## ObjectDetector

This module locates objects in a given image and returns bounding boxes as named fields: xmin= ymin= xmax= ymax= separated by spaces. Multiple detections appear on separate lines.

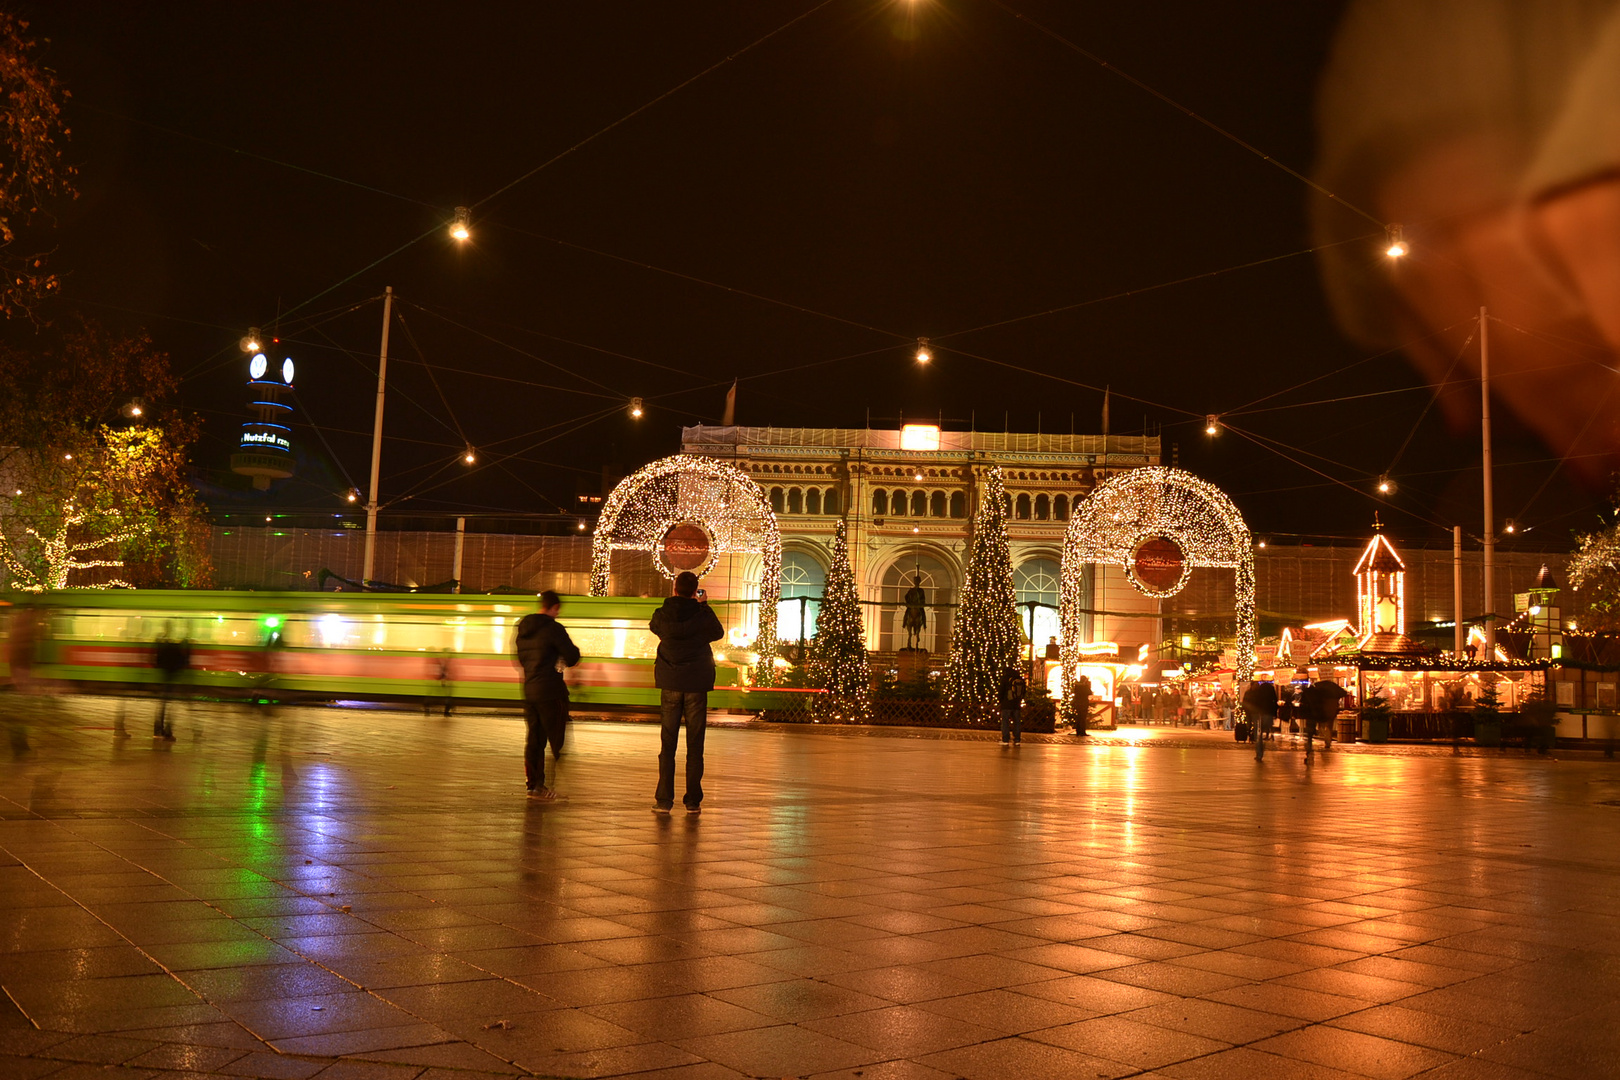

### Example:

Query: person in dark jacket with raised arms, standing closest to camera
xmin=646 ymin=570 xmax=726 ymax=814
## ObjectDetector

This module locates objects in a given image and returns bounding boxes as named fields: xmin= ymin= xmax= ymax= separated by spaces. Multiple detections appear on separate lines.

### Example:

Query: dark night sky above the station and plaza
xmin=19 ymin=0 xmax=1602 ymax=542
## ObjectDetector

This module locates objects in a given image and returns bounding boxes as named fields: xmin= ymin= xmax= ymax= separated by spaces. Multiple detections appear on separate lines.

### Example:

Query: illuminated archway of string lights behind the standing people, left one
xmin=591 ymin=453 xmax=782 ymax=670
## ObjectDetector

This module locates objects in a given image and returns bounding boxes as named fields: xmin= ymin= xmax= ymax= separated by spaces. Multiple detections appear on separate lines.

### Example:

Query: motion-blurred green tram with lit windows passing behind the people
xmin=0 ymin=589 xmax=805 ymax=711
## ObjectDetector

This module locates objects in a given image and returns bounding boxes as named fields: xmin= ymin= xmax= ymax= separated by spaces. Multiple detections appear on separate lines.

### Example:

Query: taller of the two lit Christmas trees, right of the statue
xmin=944 ymin=468 xmax=1021 ymax=717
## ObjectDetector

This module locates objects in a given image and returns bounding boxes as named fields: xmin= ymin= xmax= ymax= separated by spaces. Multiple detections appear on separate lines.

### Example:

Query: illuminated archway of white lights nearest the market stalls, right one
xmin=1058 ymin=466 xmax=1254 ymax=695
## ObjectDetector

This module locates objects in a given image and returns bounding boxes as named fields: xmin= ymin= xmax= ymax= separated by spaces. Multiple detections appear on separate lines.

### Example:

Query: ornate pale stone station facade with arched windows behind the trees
xmin=680 ymin=424 xmax=1160 ymax=659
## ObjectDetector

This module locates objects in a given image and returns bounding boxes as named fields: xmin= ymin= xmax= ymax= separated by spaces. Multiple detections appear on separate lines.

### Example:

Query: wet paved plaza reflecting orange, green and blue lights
xmin=0 ymin=698 xmax=1620 ymax=1080
